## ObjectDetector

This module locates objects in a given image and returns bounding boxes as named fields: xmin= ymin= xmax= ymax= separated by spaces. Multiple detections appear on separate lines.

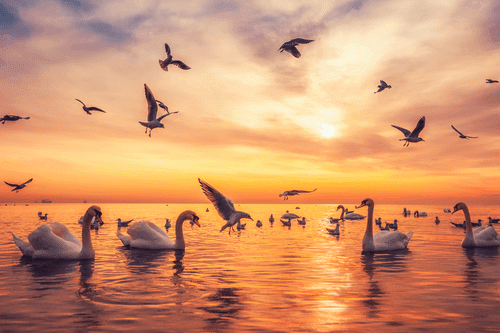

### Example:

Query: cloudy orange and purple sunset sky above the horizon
xmin=0 ymin=0 xmax=500 ymax=206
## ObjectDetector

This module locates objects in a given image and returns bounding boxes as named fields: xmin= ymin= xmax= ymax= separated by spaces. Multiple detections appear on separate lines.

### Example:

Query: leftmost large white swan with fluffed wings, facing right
xmin=12 ymin=206 xmax=102 ymax=259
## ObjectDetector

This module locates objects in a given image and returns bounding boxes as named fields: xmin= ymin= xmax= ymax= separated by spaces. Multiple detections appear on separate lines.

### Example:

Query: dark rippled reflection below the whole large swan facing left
xmin=361 ymin=250 xmax=411 ymax=318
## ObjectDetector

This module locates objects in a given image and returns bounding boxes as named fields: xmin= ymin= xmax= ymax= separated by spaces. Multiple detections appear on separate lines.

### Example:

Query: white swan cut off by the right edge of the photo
xmin=452 ymin=202 xmax=500 ymax=247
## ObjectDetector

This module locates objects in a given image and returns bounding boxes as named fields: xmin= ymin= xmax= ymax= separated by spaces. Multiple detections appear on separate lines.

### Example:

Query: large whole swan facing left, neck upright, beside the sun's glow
xmin=356 ymin=198 xmax=413 ymax=252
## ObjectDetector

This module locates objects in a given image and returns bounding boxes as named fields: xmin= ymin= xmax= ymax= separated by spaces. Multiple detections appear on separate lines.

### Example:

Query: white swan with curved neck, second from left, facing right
xmin=116 ymin=210 xmax=200 ymax=250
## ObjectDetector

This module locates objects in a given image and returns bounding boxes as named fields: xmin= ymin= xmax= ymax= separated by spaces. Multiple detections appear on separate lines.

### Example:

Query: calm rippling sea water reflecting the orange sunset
xmin=0 ymin=203 xmax=500 ymax=332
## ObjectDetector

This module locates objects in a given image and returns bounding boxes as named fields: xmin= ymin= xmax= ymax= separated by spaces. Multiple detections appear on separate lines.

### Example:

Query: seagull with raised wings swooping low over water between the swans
xmin=198 ymin=178 xmax=253 ymax=234
